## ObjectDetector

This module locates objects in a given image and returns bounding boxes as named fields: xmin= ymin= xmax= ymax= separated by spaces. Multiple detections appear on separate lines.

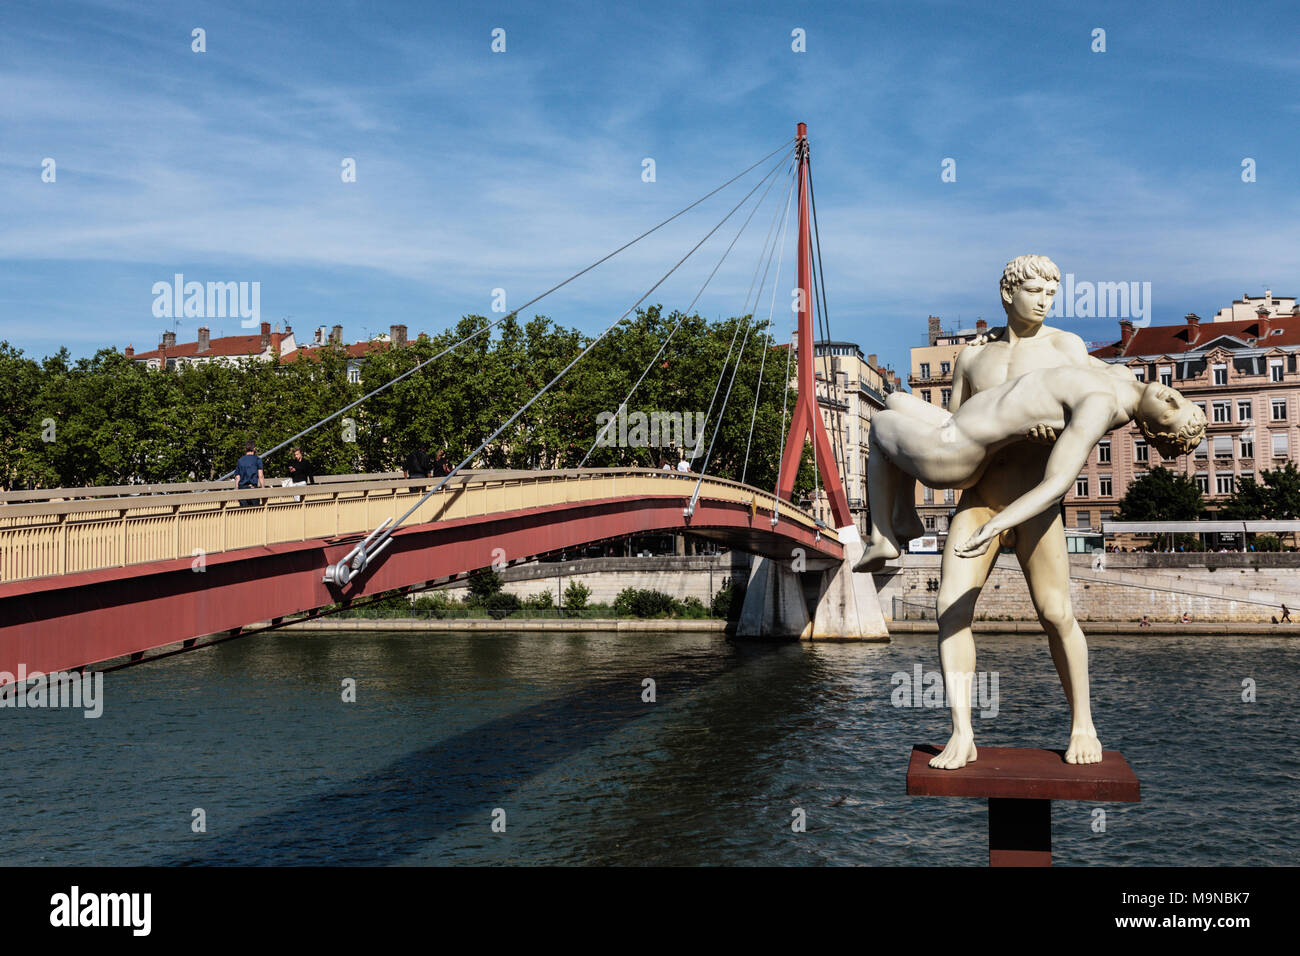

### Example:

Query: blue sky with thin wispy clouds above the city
xmin=0 ymin=0 xmax=1300 ymax=382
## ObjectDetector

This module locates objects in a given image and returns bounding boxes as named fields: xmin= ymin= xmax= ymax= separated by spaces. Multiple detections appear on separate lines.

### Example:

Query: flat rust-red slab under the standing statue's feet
xmin=907 ymin=745 xmax=1141 ymax=803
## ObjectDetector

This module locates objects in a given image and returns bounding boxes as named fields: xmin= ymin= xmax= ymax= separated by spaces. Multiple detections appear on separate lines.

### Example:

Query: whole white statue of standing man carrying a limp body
xmin=859 ymin=255 xmax=1204 ymax=770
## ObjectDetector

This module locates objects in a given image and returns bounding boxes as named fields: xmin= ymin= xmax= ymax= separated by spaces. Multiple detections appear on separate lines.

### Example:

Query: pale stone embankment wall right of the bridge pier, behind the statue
xmin=875 ymin=554 xmax=1300 ymax=622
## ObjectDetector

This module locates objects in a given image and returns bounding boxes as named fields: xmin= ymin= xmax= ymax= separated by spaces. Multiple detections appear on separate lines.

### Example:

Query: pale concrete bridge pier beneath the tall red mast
xmin=736 ymin=524 xmax=889 ymax=641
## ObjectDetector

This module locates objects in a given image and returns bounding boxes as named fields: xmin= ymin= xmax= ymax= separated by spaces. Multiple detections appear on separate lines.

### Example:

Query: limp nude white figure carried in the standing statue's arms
xmin=854 ymin=365 xmax=1205 ymax=571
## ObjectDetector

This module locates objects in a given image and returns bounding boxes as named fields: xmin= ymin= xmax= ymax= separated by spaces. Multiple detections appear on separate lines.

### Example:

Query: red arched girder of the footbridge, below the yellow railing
xmin=0 ymin=497 xmax=842 ymax=674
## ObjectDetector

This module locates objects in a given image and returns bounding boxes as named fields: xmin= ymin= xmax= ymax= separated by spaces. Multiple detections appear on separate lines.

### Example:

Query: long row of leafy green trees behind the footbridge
xmin=0 ymin=306 xmax=813 ymax=494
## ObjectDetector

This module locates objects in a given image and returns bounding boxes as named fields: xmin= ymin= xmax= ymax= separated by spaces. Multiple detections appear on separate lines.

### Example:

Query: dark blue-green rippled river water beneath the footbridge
xmin=0 ymin=631 xmax=1300 ymax=865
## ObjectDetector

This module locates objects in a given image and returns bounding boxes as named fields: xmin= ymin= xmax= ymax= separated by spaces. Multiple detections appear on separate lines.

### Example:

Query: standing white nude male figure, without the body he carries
xmin=930 ymin=255 xmax=1105 ymax=770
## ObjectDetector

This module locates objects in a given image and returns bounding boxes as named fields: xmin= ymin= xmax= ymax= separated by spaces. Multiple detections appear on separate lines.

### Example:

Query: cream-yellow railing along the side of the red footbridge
xmin=0 ymin=468 xmax=839 ymax=583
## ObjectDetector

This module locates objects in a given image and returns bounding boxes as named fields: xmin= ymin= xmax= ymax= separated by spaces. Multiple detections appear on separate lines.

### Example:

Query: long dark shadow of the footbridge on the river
xmin=159 ymin=646 xmax=781 ymax=865
